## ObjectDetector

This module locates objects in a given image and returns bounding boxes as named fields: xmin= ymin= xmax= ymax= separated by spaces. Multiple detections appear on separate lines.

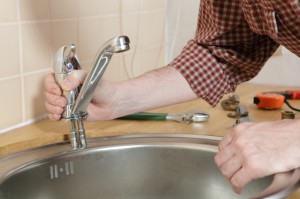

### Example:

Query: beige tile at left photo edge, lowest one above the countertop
xmin=0 ymin=78 xmax=22 ymax=129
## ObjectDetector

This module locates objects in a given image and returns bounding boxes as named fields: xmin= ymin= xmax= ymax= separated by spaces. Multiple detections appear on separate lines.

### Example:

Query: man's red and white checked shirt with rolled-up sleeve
xmin=169 ymin=0 xmax=300 ymax=106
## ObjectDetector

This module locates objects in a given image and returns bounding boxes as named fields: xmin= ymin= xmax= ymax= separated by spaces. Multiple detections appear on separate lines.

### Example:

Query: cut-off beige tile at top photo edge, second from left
xmin=19 ymin=0 xmax=49 ymax=21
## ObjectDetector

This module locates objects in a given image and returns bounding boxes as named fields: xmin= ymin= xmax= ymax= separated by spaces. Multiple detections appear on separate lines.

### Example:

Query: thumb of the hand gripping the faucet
xmin=61 ymin=70 xmax=87 ymax=91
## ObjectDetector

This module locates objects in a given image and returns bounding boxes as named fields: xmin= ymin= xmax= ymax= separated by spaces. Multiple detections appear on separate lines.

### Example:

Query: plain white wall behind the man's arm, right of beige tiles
xmin=166 ymin=0 xmax=300 ymax=87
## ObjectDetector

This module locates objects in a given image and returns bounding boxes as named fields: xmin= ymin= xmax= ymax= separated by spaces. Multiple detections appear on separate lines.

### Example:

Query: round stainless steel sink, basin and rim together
xmin=0 ymin=134 xmax=286 ymax=199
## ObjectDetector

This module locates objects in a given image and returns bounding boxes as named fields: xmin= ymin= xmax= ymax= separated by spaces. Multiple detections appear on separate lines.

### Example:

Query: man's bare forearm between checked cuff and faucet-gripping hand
xmin=113 ymin=66 xmax=197 ymax=117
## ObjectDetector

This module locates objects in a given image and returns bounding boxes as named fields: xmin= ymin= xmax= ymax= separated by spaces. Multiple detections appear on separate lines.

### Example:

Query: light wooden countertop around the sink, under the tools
xmin=0 ymin=83 xmax=300 ymax=199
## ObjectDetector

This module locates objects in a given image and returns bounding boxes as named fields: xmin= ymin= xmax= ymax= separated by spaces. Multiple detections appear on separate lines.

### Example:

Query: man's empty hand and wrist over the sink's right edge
xmin=215 ymin=120 xmax=300 ymax=193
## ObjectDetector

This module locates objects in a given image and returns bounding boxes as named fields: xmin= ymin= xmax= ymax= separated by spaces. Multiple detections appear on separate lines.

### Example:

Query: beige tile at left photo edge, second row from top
xmin=0 ymin=25 xmax=20 ymax=78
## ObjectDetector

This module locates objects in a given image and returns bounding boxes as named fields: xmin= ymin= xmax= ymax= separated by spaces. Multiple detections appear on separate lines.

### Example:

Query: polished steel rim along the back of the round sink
xmin=0 ymin=133 xmax=222 ymax=180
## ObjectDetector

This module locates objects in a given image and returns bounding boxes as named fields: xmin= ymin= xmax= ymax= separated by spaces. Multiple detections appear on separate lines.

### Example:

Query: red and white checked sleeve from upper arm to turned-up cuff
xmin=169 ymin=0 xmax=279 ymax=106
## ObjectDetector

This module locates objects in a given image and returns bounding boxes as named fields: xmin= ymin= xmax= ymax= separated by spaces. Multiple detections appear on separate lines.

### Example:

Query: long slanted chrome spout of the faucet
xmin=72 ymin=36 xmax=130 ymax=117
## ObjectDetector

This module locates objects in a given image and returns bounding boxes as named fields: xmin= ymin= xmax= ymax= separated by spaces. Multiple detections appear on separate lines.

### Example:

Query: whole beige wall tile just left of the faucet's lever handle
xmin=22 ymin=23 xmax=52 ymax=72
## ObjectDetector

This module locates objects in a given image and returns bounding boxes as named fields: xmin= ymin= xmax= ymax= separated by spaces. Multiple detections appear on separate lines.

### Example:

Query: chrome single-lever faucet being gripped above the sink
xmin=53 ymin=36 xmax=130 ymax=149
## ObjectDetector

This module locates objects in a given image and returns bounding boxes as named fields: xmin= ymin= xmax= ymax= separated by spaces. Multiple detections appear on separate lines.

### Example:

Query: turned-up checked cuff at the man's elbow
xmin=169 ymin=40 xmax=236 ymax=107
